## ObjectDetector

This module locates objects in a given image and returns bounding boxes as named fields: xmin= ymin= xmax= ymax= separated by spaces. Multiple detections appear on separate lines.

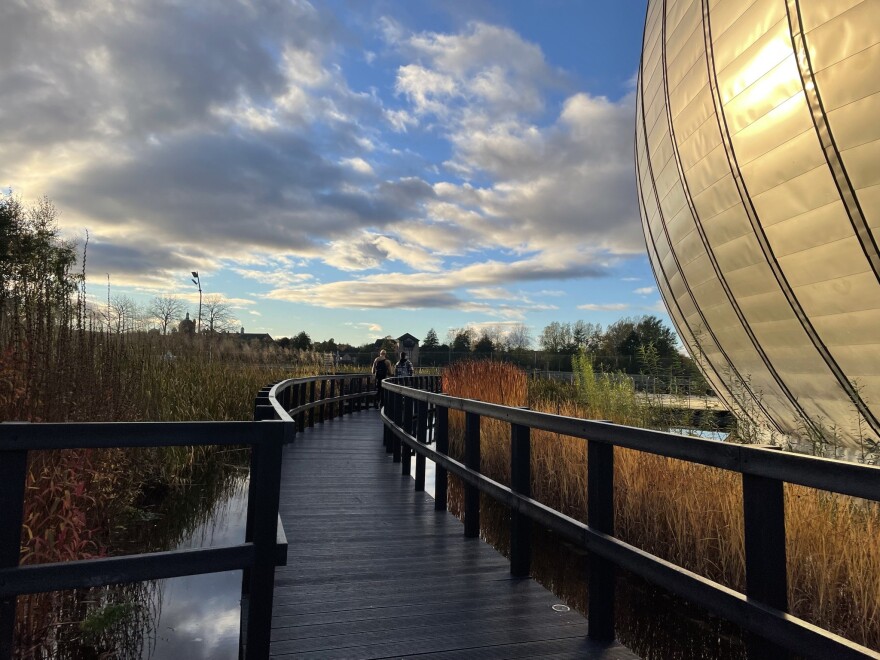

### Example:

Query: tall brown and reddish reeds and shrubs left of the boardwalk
xmin=0 ymin=196 xmax=334 ymax=658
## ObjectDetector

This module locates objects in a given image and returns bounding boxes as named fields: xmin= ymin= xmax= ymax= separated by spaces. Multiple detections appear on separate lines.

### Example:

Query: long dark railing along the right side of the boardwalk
xmin=382 ymin=377 xmax=880 ymax=658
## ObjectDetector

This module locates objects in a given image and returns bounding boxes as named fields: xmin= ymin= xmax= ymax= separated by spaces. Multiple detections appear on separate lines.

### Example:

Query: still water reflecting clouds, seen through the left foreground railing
xmin=141 ymin=478 xmax=247 ymax=660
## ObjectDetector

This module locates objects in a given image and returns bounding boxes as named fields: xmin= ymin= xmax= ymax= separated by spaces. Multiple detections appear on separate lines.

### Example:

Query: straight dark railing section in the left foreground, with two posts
xmin=0 ymin=422 xmax=292 ymax=659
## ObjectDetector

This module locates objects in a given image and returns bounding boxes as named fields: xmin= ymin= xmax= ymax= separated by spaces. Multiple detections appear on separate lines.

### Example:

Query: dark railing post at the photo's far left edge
xmin=0 ymin=451 xmax=27 ymax=658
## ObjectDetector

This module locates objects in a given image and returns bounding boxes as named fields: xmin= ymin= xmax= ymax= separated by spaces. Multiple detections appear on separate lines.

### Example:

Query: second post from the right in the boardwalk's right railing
xmin=587 ymin=440 xmax=615 ymax=641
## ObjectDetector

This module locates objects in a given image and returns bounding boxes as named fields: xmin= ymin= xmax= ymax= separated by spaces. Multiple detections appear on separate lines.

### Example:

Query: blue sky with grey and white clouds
xmin=0 ymin=0 xmax=668 ymax=345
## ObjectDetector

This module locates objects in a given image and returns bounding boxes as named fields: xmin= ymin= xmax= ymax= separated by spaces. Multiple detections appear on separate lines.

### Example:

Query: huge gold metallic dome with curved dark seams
xmin=635 ymin=0 xmax=880 ymax=457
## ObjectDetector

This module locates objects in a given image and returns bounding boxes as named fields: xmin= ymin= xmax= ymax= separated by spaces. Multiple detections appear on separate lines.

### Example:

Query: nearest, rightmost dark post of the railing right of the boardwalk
xmin=742 ymin=473 xmax=788 ymax=658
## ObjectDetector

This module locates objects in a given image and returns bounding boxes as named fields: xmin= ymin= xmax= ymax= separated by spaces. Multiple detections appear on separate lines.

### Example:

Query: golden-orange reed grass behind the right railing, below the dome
xmin=443 ymin=362 xmax=880 ymax=649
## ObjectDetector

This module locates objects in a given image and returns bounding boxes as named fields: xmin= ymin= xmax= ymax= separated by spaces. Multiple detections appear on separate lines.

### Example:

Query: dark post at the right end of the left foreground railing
xmin=245 ymin=423 xmax=283 ymax=660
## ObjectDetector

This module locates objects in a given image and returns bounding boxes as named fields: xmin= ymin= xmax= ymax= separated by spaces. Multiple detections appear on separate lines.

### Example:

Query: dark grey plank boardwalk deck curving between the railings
xmin=272 ymin=410 xmax=635 ymax=660
